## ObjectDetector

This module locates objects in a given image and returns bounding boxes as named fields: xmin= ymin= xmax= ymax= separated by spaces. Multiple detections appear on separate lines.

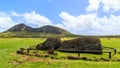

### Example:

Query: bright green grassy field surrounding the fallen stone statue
xmin=0 ymin=38 xmax=120 ymax=68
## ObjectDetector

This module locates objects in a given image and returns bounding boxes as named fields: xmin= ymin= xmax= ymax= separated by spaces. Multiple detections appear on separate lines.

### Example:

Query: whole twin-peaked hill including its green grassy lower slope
xmin=0 ymin=23 xmax=74 ymax=37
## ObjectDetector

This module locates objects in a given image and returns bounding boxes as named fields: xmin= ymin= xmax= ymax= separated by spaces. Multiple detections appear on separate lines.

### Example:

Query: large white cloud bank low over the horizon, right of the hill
xmin=60 ymin=12 xmax=120 ymax=35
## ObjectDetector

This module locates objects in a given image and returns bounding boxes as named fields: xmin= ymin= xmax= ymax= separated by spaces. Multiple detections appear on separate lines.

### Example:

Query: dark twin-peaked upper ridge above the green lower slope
xmin=5 ymin=23 xmax=70 ymax=34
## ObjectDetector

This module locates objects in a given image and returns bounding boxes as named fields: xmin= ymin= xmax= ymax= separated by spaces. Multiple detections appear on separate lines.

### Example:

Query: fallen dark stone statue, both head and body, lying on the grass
xmin=36 ymin=37 xmax=102 ymax=53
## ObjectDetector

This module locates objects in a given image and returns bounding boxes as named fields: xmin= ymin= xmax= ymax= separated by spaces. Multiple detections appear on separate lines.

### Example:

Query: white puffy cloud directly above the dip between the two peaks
xmin=23 ymin=11 xmax=52 ymax=26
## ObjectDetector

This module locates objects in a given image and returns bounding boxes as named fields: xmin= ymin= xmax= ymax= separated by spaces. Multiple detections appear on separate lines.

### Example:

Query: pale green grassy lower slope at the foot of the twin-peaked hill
xmin=0 ymin=31 xmax=77 ymax=38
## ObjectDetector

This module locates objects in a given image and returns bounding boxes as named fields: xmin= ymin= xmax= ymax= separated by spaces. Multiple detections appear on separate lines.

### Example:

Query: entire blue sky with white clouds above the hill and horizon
xmin=0 ymin=0 xmax=120 ymax=35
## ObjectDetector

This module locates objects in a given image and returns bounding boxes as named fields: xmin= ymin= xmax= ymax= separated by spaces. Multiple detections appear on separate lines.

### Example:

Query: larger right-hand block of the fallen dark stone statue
xmin=59 ymin=37 xmax=102 ymax=53
